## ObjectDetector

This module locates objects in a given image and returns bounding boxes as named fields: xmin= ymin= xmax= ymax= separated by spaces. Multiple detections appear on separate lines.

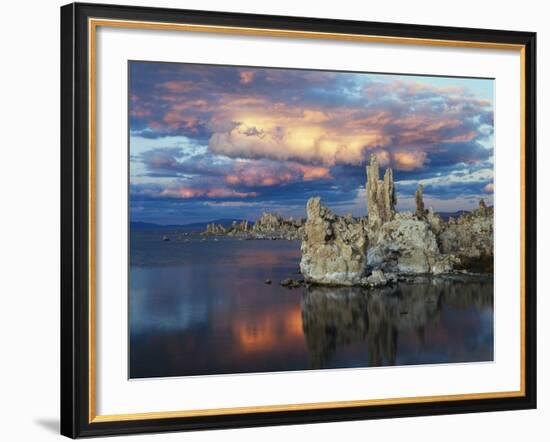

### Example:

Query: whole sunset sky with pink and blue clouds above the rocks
xmin=128 ymin=61 xmax=494 ymax=224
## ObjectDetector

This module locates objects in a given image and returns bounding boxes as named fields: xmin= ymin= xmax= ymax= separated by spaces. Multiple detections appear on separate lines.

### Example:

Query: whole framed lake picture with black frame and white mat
xmin=61 ymin=4 xmax=536 ymax=438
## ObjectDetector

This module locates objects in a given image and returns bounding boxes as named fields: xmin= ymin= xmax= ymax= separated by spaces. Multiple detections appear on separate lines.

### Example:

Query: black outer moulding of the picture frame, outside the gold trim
xmin=60 ymin=3 xmax=537 ymax=438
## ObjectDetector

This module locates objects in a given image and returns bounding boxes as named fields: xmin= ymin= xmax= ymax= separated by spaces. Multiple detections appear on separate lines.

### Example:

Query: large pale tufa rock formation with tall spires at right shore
xmin=300 ymin=155 xmax=493 ymax=287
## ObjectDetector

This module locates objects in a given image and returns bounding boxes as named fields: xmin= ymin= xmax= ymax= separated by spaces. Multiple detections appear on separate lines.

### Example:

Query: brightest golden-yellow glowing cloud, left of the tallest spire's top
xmin=208 ymin=107 xmax=390 ymax=166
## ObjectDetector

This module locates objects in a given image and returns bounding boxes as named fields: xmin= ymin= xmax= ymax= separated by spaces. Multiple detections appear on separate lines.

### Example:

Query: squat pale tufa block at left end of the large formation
xmin=300 ymin=197 xmax=367 ymax=285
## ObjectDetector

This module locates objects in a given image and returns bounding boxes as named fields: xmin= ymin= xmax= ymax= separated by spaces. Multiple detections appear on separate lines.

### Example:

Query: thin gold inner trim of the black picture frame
xmin=88 ymin=18 xmax=526 ymax=423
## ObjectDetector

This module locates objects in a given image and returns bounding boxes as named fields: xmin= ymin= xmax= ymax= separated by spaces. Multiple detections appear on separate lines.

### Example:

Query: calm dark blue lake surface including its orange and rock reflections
xmin=129 ymin=230 xmax=493 ymax=378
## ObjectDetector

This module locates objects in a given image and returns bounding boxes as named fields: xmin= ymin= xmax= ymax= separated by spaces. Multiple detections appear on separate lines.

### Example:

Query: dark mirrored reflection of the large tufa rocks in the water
xmin=301 ymin=279 xmax=493 ymax=368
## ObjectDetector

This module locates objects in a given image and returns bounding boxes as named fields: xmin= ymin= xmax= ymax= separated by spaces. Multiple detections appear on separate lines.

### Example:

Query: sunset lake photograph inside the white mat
xmin=127 ymin=60 xmax=496 ymax=379
